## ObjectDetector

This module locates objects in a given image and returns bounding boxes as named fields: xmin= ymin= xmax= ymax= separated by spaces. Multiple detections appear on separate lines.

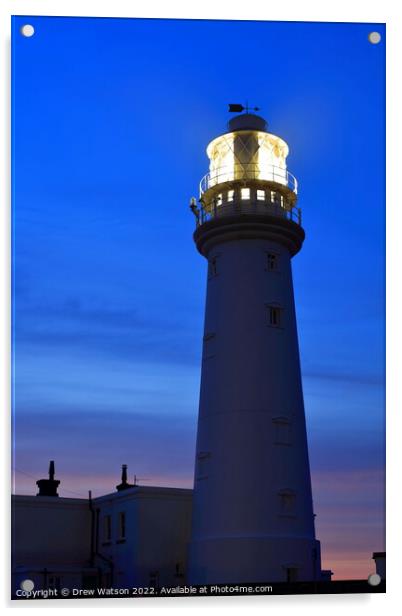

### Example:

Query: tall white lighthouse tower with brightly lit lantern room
xmin=188 ymin=113 xmax=321 ymax=584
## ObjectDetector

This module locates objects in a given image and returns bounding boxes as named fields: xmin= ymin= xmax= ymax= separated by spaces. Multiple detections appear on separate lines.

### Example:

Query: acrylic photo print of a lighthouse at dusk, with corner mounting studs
xmin=12 ymin=17 xmax=385 ymax=599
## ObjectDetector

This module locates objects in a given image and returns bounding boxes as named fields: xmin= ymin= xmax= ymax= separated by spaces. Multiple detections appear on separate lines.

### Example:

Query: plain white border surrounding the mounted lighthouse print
xmin=0 ymin=0 xmax=402 ymax=615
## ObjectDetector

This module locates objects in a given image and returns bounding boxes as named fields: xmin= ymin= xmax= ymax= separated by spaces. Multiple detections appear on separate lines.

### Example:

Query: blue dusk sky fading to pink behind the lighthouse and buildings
xmin=12 ymin=17 xmax=385 ymax=577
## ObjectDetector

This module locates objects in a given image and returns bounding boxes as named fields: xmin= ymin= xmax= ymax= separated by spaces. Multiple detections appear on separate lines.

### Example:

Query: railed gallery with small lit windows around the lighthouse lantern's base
xmin=191 ymin=164 xmax=301 ymax=227
